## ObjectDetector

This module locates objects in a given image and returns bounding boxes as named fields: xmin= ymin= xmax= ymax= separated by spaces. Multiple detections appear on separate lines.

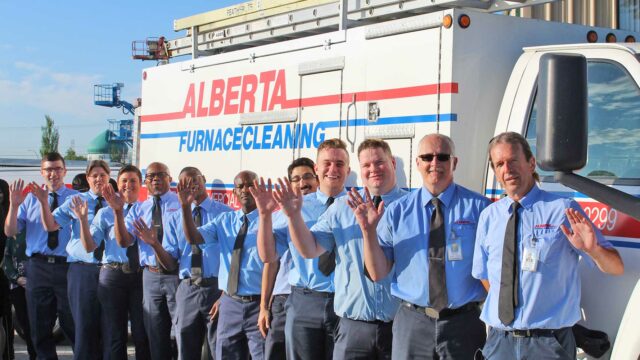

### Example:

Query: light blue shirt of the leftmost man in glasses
xmin=17 ymin=186 xmax=78 ymax=257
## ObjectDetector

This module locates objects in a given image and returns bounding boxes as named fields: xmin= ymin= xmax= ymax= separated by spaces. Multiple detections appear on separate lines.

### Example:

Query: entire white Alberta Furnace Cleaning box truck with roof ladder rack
xmin=134 ymin=0 xmax=640 ymax=359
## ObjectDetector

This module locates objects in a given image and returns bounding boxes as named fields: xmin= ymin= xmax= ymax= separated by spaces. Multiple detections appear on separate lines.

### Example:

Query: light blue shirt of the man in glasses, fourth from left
xmin=124 ymin=191 xmax=181 ymax=266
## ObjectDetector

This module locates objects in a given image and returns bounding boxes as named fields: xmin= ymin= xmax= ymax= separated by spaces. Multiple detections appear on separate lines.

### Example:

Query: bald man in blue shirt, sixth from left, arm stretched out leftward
xmin=183 ymin=170 xmax=264 ymax=360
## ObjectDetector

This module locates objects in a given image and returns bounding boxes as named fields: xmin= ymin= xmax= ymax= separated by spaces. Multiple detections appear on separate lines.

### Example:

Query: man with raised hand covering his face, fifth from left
xmin=168 ymin=167 xmax=231 ymax=360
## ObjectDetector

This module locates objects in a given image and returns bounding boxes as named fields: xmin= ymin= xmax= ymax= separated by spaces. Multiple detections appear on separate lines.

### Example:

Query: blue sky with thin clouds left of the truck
xmin=0 ymin=0 xmax=238 ymax=159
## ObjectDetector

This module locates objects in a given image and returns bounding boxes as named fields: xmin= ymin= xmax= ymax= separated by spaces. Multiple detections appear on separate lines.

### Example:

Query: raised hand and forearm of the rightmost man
xmin=561 ymin=208 xmax=624 ymax=275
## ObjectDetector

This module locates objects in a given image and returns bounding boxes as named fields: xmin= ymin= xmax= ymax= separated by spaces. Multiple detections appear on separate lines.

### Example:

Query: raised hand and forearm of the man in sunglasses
xmin=348 ymin=188 xmax=393 ymax=281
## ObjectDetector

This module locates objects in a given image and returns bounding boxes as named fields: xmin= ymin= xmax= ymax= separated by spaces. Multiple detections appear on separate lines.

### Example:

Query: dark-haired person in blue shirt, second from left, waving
xmin=34 ymin=160 xmax=111 ymax=360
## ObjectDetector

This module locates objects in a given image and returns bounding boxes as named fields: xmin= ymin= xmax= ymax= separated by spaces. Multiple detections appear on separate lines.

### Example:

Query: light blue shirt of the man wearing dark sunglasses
xmin=378 ymin=183 xmax=489 ymax=309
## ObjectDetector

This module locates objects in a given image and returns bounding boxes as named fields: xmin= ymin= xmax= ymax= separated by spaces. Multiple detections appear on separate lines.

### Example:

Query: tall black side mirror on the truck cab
xmin=536 ymin=54 xmax=588 ymax=172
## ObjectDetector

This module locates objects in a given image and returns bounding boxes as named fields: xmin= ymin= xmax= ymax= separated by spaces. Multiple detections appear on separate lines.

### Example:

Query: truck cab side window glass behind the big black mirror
xmin=526 ymin=61 xmax=640 ymax=185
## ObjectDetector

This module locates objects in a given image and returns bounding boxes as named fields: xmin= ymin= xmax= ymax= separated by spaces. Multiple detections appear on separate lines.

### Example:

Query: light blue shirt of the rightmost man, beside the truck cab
xmin=473 ymin=185 xmax=612 ymax=330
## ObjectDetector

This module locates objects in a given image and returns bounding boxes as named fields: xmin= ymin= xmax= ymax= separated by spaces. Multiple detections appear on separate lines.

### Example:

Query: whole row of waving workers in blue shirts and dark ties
xmin=4 ymin=132 xmax=624 ymax=360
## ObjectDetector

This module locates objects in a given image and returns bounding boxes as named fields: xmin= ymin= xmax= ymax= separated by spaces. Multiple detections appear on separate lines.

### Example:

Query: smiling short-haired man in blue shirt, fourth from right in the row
xmin=252 ymin=139 xmax=350 ymax=360
